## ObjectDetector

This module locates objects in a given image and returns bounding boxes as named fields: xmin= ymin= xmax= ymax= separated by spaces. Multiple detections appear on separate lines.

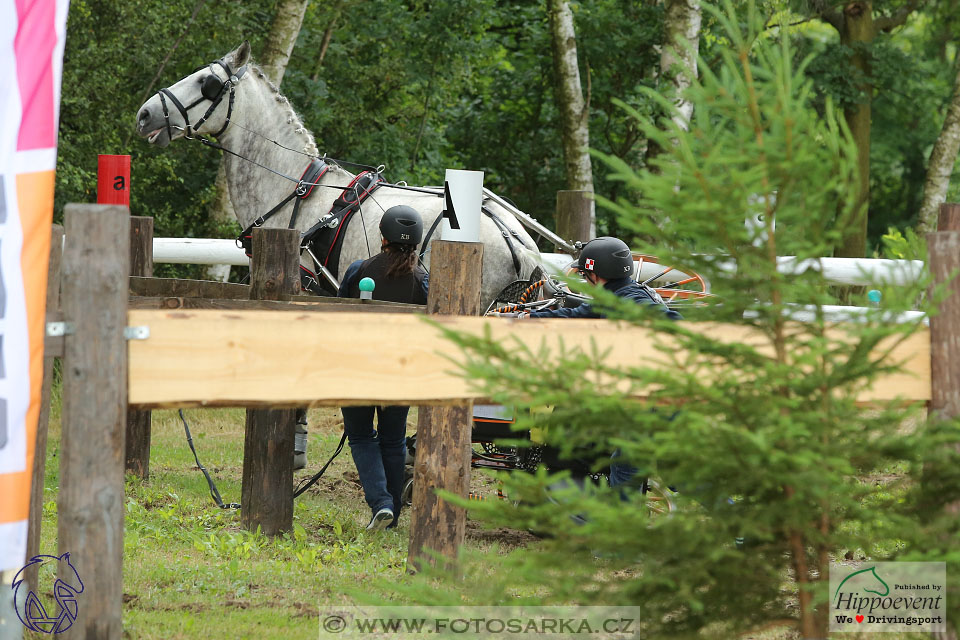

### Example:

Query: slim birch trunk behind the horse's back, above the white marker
xmin=547 ymin=0 xmax=597 ymax=237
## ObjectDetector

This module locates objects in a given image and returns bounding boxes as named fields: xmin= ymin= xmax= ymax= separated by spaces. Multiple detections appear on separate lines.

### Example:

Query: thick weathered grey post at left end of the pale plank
xmin=57 ymin=204 xmax=130 ymax=640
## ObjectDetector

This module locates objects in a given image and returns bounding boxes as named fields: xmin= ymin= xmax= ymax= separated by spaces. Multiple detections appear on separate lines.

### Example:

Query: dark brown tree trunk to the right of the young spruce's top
xmin=835 ymin=0 xmax=877 ymax=258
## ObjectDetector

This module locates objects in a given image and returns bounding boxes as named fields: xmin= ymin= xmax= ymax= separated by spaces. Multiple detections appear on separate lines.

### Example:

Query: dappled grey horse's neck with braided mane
xmin=220 ymin=69 xmax=353 ymax=230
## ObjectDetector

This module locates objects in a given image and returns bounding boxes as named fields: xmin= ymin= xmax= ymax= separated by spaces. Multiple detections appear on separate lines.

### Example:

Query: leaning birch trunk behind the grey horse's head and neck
xmin=207 ymin=0 xmax=308 ymax=281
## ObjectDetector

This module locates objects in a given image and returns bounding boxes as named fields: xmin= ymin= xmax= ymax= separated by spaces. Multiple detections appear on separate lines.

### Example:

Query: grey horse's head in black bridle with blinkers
xmin=137 ymin=41 xmax=250 ymax=147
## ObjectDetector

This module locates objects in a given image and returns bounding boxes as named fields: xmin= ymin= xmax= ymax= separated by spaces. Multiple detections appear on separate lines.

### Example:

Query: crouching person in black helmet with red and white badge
xmin=530 ymin=236 xmax=681 ymax=320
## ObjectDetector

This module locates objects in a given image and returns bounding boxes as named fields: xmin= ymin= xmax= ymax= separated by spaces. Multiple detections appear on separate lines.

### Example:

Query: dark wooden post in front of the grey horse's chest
xmin=240 ymin=228 xmax=300 ymax=536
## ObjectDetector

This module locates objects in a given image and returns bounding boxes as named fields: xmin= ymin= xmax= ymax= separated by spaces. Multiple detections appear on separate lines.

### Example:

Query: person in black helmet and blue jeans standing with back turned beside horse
xmin=337 ymin=205 xmax=428 ymax=529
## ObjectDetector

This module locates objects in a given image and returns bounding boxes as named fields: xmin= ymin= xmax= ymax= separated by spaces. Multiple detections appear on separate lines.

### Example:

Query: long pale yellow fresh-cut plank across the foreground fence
xmin=128 ymin=310 xmax=930 ymax=407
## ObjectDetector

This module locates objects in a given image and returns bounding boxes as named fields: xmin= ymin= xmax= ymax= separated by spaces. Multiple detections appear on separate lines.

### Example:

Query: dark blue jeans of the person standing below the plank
xmin=340 ymin=406 xmax=410 ymax=523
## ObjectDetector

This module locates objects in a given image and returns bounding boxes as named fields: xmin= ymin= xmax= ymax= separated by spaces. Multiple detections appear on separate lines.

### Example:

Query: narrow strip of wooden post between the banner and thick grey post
xmin=27 ymin=224 xmax=63 ymax=588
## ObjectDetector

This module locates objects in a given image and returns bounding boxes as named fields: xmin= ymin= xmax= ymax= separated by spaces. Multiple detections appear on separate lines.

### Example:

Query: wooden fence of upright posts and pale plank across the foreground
xmin=28 ymin=205 xmax=960 ymax=638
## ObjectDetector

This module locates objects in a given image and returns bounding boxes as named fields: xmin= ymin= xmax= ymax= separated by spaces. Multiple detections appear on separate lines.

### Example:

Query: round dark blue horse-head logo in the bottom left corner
xmin=13 ymin=553 xmax=83 ymax=633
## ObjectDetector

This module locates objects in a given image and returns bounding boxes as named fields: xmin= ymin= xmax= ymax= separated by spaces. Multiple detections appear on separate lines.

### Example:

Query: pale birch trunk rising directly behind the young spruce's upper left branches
xmin=660 ymin=0 xmax=702 ymax=130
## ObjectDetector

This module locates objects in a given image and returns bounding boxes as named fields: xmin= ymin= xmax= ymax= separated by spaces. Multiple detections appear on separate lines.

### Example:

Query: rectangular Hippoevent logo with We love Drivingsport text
xmin=830 ymin=562 xmax=947 ymax=633
